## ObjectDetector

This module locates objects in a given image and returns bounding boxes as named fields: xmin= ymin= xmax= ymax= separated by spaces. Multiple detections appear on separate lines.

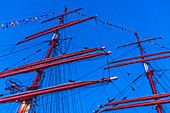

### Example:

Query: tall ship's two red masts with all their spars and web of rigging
xmin=0 ymin=6 xmax=170 ymax=113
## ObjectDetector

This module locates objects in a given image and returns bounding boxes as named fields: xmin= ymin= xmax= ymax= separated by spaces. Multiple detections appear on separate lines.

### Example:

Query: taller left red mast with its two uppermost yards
xmin=14 ymin=7 xmax=97 ymax=113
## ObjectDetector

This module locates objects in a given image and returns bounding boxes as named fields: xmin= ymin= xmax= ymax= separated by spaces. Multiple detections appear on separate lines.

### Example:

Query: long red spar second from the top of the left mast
xmin=16 ymin=16 xmax=97 ymax=45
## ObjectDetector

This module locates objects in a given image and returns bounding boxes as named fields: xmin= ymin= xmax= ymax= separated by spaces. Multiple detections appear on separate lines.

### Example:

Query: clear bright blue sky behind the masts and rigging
xmin=0 ymin=0 xmax=170 ymax=113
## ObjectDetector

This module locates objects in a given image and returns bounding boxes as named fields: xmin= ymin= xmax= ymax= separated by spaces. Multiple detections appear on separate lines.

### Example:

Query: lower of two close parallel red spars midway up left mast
xmin=0 ymin=51 xmax=111 ymax=78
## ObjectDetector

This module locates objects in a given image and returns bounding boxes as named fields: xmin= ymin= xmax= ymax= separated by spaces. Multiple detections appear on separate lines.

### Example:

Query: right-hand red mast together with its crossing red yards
xmin=94 ymin=33 xmax=170 ymax=113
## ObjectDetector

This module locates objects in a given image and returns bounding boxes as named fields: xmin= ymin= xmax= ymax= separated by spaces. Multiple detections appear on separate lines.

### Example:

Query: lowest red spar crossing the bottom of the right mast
xmin=94 ymin=99 xmax=170 ymax=113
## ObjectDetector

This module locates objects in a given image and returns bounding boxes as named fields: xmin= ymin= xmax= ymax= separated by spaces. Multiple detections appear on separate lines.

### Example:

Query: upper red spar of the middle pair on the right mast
xmin=108 ymin=51 xmax=170 ymax=64
